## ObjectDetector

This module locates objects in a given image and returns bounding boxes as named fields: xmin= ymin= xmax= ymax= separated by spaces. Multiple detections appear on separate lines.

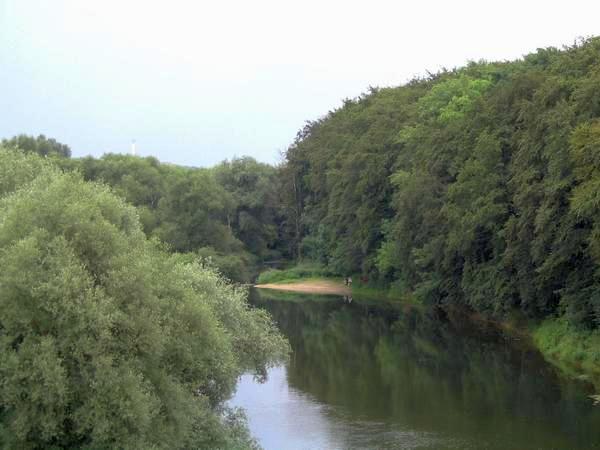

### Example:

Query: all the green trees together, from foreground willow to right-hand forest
xmin=0 ymin=38 xmax=600 ymax=448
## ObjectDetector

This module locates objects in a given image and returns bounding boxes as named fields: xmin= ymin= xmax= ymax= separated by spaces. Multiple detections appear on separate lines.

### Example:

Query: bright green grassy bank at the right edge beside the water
xmin=532 ymin=319 xmax=600 ymax=391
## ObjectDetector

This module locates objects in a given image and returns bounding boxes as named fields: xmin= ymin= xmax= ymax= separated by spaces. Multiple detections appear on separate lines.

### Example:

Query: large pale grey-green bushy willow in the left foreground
xmin=0 ymin=150 xmax=287 ymax=449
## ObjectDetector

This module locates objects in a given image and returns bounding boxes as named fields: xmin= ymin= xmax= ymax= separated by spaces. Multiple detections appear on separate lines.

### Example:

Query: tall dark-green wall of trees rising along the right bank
xmin=281 ymin=38 xmax=600 ymax=328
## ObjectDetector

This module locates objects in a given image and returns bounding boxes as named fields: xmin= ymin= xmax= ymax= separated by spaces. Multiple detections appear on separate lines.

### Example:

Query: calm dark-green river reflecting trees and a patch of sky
xmin=231 ymin=291 xmax=600 ymax=450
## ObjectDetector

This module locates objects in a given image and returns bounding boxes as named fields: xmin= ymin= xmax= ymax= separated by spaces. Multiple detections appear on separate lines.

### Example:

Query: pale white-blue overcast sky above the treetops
xmin=0 ymin=0 xmax=600 ymax=166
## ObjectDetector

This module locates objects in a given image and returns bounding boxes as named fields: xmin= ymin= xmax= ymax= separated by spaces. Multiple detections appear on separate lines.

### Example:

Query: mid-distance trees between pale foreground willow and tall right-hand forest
xmin=60 ymin=155 xmax=290 ymax=282
